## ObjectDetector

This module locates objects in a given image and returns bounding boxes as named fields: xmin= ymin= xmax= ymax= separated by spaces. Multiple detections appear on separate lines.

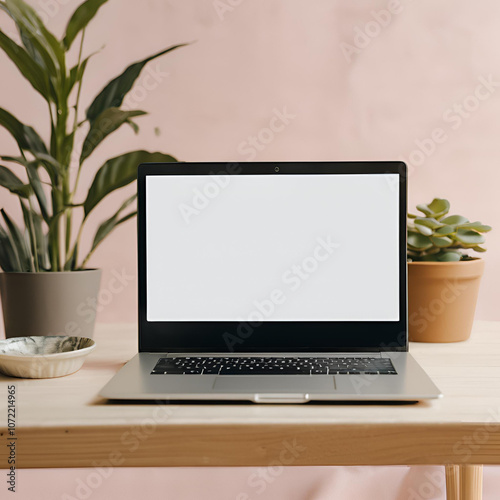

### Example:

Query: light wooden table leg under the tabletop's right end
xmin=446 ymin=465 xmax=483 ymax=500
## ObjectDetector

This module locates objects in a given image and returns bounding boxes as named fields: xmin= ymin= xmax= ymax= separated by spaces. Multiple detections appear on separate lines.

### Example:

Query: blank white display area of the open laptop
xmin=146 ymin=174 xmax=399 ymax=322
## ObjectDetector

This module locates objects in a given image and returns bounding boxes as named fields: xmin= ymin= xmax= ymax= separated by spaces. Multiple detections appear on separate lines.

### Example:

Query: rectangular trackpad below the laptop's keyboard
xmin=213 ymin=375 xmax=336 ymax=394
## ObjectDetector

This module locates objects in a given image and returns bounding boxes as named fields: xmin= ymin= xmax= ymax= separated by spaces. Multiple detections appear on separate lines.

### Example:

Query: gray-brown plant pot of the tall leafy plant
xmin=0 ymin=269 xmax=101 ymax=338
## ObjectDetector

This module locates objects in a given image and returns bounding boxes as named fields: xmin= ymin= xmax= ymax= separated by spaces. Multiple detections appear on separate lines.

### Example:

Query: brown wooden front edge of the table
xmin=7 ymin=424 xmax=500 ymax=467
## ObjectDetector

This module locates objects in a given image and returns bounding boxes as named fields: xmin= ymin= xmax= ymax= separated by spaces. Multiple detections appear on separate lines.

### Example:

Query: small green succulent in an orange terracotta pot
xmin=408 ymin=198 xmax=491 ymax=342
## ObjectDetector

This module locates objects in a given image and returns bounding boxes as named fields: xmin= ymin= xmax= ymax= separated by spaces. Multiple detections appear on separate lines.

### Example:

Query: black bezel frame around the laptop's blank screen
xmin=137 ymin=162 xmax=408 ymax=353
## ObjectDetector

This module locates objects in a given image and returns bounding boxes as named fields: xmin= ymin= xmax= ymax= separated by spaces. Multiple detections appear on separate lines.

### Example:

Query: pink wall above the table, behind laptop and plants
xmin=0 ymin=0 xmax=500 ymax=321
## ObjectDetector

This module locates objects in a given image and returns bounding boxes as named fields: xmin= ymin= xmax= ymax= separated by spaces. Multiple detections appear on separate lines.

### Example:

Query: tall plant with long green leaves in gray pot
xmin=0 ymin=0 xmax=186 ymax=337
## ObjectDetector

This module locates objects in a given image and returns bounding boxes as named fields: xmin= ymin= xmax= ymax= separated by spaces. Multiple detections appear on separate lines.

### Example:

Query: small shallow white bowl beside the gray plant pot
xmin=0 ymin=335 xmax=96 ymax=378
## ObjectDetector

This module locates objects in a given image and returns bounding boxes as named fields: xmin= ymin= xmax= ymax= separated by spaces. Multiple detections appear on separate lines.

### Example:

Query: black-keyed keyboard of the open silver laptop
xmin=151 ymin=356 xmax=396 ymax=375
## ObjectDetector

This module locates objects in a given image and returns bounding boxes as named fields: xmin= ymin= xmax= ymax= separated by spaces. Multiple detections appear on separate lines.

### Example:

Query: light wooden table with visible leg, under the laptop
xmin=0 ymin=322 xmax=500 ymax=500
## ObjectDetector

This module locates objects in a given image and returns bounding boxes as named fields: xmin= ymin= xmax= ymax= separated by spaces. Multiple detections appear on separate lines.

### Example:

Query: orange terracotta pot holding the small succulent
xmin=408 ymin=259 xmax=484 ymax=342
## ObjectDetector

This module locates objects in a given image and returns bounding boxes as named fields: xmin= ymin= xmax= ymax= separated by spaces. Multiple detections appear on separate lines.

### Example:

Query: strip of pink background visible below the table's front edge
xmin=11 ymin=465 xmax=498 ymax=500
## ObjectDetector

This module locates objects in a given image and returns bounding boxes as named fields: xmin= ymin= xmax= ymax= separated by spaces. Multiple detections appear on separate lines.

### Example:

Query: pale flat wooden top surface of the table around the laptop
xmin=0 ymin=321 xmax=500 ymax=427
